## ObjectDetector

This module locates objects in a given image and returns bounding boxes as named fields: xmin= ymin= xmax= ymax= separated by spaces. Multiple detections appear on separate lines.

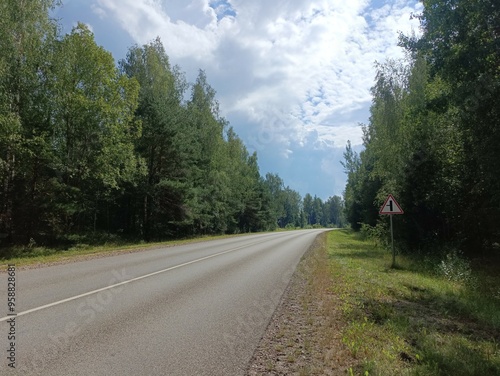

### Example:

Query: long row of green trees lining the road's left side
xmin=0 ymin=0 xmax=345 ymax=252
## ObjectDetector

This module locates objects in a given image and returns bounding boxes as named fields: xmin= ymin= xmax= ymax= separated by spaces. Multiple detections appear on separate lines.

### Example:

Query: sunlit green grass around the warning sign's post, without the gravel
xmin=328 ymin=230 xmax=500 ymax=376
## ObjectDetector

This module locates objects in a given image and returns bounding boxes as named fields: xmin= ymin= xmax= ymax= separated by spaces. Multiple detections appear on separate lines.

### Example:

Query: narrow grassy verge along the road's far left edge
xmin=0 ymin=234 xmax=250 ymax=271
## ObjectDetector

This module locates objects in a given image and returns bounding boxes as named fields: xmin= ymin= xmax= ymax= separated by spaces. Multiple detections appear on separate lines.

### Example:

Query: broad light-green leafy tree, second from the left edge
xmin=50 ymin=24 xmax=141 ymax=220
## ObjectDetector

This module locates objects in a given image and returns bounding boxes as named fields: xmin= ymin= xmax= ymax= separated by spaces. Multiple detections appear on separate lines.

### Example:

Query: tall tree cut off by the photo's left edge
xmin=0 ymin=0 xmax=60 ymax=242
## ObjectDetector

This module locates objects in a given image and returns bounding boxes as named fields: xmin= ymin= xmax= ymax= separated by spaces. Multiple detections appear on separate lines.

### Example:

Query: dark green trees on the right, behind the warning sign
xmin=343 ymin=0 xmax=500 ymax=256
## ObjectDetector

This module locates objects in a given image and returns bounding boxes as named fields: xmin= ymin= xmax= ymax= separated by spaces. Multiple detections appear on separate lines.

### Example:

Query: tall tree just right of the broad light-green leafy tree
xmin=119 ymin=39 xmax=192 ymax=240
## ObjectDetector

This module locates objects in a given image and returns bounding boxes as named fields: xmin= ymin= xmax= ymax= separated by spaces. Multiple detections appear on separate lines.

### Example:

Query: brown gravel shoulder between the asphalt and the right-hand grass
xmin=247 ymin=233 xmax=358 ymax=376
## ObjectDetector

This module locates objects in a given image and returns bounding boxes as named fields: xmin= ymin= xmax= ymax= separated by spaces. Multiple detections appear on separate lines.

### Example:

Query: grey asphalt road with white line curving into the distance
xmin=0 ymin=230 xmax=324 ymax=376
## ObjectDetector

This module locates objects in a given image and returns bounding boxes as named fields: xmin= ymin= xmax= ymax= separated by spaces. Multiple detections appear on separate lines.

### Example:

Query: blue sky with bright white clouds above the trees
xmin=54 ymin=0 xmax=422 ymax=200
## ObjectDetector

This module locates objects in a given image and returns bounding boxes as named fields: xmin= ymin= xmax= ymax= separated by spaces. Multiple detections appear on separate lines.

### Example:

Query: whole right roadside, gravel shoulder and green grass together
xmin=247 ymin=230 xmax=500 ymax=376
